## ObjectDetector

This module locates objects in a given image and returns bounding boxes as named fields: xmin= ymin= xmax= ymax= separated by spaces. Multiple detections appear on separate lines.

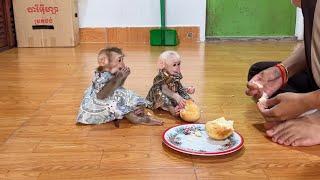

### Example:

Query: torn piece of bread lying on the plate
xmin=206 ymin=117 xmax=234 ymax=140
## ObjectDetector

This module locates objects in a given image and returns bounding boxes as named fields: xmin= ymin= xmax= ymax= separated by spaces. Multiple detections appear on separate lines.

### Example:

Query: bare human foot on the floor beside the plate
xmin=267 ymin=113 xmax=320 ymax=146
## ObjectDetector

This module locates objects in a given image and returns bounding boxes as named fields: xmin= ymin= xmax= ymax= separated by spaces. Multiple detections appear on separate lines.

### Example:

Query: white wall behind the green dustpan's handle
xmin=78 ymin=0 xmax=206 ymax=41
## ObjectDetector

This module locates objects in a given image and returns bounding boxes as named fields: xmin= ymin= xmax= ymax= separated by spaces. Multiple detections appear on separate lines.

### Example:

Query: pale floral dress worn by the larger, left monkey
xmin=77 ymin=71 xmax=150 ymax=124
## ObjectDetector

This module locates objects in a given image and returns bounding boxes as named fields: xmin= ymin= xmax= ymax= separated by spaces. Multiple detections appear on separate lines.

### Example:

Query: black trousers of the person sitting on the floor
xmin=248 ymin=62 xmax=319 ymax=95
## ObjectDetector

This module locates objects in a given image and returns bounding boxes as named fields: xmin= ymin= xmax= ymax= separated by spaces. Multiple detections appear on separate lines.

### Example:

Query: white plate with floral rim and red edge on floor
xmin=162 ymin=124 xmax=243 ymax=156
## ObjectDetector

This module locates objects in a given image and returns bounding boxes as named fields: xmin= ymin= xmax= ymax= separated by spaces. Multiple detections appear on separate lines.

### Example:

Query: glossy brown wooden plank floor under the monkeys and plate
xmin=0 ymin=42 xmax=320 ymax=179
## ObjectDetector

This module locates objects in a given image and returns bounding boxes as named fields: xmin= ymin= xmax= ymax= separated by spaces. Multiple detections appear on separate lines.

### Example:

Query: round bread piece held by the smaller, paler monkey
xmin=180 ymin=100 xmax=200 ymax=122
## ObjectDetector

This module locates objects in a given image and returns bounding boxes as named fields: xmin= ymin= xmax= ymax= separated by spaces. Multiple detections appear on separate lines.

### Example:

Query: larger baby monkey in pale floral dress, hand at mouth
xmin=77 ymin=47 xmax=163 ymax=127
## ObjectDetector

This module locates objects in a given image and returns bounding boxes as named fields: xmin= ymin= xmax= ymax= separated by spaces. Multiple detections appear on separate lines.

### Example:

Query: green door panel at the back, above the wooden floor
xmin=206 ymin=0 xmax=296 ymax=37
